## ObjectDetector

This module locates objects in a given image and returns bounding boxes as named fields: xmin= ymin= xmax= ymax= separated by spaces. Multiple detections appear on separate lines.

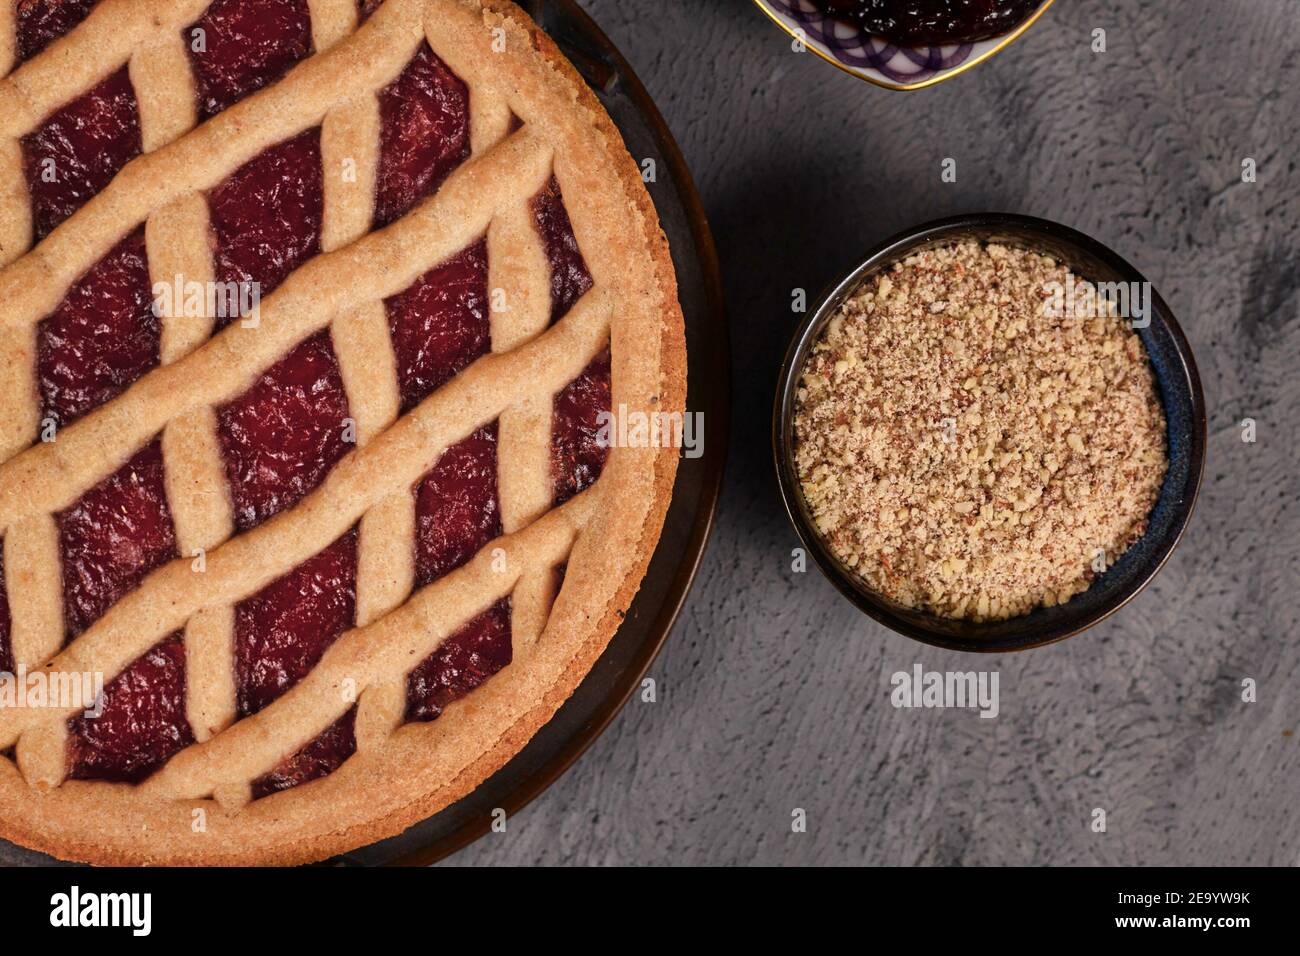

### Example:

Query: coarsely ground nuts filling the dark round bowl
xmin=794 ymin=242 xmax=1167 ymax=620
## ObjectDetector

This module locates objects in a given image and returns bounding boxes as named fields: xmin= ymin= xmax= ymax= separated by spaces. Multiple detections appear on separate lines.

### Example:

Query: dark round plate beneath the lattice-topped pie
xmin=0 ymin=0 xmax=731 ymax=866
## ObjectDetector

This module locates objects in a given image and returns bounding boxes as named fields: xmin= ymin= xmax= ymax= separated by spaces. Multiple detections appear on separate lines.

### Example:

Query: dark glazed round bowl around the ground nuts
xmin=772 ymin=213 xmax=1205 ymax=653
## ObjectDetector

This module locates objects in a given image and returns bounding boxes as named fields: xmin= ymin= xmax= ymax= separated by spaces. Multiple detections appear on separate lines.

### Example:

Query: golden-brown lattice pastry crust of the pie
xmin=0 ymin=0 xmax=685 ymax=864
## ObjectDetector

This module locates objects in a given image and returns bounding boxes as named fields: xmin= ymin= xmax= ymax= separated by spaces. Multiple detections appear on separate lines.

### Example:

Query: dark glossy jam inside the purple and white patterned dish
xmin=813 ymin=0 xmax=1043 ymax=47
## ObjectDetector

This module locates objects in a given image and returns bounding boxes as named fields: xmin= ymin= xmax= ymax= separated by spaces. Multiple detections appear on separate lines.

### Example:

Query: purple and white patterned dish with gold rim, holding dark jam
xmin=754 ymin=0 xmax=1056 ymax=90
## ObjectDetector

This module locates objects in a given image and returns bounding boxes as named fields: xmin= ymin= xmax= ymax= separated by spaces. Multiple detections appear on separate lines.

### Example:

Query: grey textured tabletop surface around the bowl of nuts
xmin=450 ymin=0 xmax=1300 ymax=865
